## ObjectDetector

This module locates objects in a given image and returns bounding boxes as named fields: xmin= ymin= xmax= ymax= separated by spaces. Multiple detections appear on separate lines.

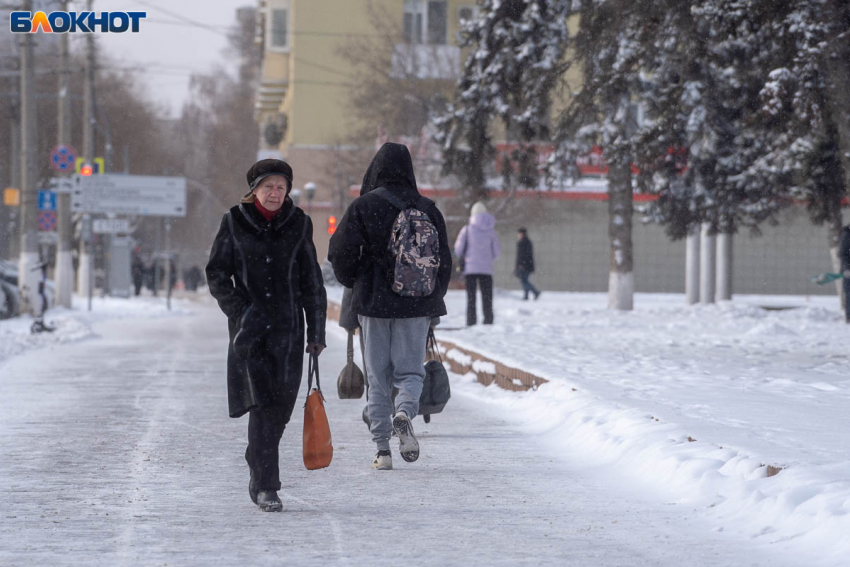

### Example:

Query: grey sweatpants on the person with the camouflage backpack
xmin=358 ymin=315 xmax=431 ymax=450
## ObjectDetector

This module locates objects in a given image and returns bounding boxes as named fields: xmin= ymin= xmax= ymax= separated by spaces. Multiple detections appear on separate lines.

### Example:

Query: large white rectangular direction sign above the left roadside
xmin=71 ymin=174 xmax=186 ymax=217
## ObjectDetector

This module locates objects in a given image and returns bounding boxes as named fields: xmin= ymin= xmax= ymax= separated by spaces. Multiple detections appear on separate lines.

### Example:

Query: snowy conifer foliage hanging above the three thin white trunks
xmin=637 ymin=0 xmax=784 ymax=242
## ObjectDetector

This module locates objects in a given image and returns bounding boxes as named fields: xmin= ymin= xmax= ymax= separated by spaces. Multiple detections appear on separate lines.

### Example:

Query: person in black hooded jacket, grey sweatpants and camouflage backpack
xmin=328 ymin=143 xmax=452 ymax=470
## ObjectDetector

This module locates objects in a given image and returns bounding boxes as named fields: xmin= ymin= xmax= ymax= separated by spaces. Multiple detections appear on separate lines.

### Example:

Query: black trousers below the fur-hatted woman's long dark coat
xmin=245 ymin=400 xmax=295 ymax=492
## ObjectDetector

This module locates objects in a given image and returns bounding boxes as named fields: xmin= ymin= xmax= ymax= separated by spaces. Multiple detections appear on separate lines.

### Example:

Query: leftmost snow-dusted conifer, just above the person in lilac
xmin=436 ymin=0 xmax=571 ymax=207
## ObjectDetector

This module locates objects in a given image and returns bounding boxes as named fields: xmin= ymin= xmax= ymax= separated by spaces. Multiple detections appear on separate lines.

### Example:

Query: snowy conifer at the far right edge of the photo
xmin=743 ymin=0 xmax=850 ymax=301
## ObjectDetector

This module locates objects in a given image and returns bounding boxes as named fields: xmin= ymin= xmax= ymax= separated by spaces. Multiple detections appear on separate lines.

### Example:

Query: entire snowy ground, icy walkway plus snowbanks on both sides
xmin=0 ymin=288 xmax=850 ymax=567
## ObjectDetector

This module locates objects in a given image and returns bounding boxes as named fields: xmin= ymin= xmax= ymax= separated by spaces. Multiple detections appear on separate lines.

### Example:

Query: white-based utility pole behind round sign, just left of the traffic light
xmin=56 ymin=0 xmax=74 ymax=309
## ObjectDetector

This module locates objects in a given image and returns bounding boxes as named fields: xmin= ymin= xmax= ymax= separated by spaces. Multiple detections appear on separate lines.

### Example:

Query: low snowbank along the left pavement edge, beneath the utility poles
xmin=0 ymin=297 xmax=192 ymax=361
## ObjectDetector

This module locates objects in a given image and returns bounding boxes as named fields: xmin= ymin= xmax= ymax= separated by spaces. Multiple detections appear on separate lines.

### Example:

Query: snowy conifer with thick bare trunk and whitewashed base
xmin=549 ymin=0 xmax=653 ymax=310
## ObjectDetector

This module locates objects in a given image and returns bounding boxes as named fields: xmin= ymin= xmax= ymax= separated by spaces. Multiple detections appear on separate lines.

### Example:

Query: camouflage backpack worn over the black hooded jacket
xmin=374 ymin=187 xmax=440 ymax=297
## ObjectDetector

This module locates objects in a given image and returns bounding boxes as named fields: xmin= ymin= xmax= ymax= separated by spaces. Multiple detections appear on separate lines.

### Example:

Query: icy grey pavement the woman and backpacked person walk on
xmin=0 ymin=300 xmax=812 ymax=567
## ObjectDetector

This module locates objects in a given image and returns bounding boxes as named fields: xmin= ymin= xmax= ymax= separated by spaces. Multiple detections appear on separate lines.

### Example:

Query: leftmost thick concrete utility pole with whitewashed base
xmin=18 ymin=0 xmax=41 ymax=315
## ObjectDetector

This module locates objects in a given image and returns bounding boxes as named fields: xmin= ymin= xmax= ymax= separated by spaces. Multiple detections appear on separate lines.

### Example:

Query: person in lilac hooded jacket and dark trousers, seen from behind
xmin=455 ymin=201 xmax=502 ymax=326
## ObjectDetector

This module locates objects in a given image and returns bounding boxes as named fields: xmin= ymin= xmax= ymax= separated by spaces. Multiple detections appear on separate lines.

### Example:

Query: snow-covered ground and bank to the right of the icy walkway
xmin=332 ymin=288 xmax=850 ymax=565
